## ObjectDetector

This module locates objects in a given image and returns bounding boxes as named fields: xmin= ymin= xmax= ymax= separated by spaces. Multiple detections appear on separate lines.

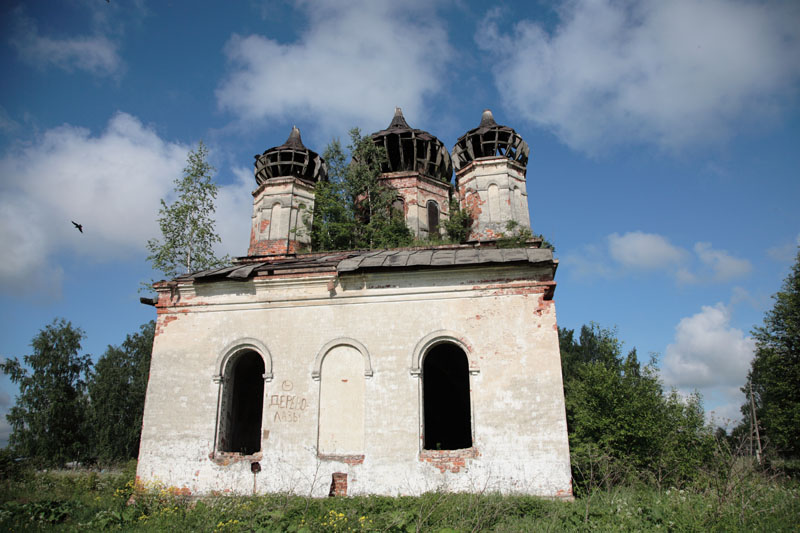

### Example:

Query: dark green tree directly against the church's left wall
xmin=89 ymin=321 xmax=155 ymax=462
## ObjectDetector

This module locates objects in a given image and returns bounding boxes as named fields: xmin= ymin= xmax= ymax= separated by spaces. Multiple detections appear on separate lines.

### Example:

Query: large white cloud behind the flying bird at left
xmin=0 ymin=113 xmax=188 ymax=290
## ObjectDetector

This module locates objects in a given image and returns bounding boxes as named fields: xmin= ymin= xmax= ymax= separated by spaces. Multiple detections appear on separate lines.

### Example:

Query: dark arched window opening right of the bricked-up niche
xmin=422 ymin=343 xmax=472 ymax=450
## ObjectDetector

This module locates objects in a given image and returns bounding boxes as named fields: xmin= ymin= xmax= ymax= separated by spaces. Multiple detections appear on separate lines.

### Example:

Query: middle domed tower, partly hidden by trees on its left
xmin=371 ymin=107 xmax=453 ymax=238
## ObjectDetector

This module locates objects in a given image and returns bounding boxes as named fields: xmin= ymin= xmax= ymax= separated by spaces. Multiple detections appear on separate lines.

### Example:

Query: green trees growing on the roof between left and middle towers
xmin=311 ymin=128 xmax=413 ymax=251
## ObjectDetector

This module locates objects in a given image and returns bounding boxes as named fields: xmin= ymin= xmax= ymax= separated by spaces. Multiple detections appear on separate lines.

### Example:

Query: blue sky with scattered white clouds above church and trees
xmin=0 ymin=0 xmax=800 ymax=444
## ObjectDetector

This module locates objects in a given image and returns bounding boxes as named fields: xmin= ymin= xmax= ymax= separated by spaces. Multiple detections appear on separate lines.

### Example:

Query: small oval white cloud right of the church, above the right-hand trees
xmin=608 ymin=231 xmax=686 ymax=270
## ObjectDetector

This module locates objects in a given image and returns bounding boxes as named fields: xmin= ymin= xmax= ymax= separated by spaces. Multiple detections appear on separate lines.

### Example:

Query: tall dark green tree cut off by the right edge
xmin=742 ymin=246 xmax=800 ymax=458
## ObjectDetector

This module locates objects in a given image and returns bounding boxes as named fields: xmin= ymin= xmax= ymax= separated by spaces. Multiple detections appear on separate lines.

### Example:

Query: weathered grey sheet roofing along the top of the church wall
xmin=170 ymin=245 xmax=558 ymax=282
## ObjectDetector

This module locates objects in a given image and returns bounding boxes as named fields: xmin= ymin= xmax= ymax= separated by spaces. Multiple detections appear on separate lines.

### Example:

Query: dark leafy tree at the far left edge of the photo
xmin=2 ymin=319 xmax=91 ymax=465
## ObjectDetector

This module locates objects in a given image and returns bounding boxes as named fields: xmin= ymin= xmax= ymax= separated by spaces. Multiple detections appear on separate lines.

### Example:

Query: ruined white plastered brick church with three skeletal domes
xmin=137 ymin=109 xmax=572 ymax=498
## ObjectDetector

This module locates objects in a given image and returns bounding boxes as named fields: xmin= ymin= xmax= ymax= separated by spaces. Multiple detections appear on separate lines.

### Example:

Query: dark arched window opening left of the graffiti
xmin=219 ymin=351 xmax=264 ymax=455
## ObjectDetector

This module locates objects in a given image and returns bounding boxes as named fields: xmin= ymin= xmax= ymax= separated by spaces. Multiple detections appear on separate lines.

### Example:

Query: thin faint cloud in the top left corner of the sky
xmin=9 ymin=12 xmax=122 ymax=76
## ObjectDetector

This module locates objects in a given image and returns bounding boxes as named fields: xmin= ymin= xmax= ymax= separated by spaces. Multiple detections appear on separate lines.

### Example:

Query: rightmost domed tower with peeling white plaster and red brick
xmin=452 ymin=109 xmax=531 ymax=241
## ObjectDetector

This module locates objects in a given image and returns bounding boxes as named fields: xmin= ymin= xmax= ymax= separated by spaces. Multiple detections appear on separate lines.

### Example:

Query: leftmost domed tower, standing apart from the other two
xmin=247 ymin=127 xmax=328 ymax=256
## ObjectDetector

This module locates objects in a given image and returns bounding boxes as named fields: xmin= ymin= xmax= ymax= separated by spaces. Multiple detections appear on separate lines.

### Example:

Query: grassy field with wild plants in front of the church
xmin=0 ymin=464 xmax=800 ymax=532
